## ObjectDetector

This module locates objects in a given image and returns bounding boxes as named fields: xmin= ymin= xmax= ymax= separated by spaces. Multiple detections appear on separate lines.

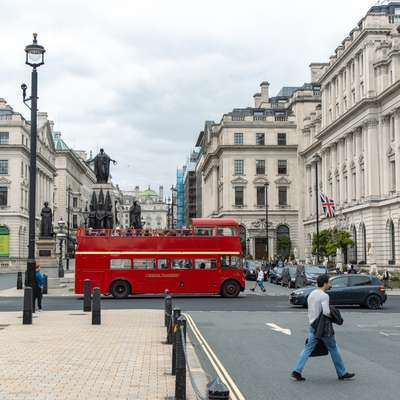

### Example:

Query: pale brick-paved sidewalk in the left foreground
xmin=0 ymin=310 xmax=195 ymax=400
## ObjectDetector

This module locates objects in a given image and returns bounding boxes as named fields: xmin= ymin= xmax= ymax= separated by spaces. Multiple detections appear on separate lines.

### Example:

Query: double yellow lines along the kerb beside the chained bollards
xmin=184 ymin=314 xmax=246 ymax=400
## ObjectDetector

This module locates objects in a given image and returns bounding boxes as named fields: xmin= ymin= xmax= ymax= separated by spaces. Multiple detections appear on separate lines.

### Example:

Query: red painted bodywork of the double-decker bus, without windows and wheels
xmin=75 ymin=218 xmax=245 ymax=294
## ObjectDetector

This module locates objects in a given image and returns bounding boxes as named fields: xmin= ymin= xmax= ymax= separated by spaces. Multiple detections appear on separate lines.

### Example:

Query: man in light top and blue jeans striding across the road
xmin=291 ymin=274 xmax=355 ymax=381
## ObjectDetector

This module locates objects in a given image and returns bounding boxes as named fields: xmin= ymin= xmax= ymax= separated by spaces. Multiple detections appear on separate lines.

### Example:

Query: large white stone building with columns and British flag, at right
xmin=299 ymin=3 xmax=400 ymax=266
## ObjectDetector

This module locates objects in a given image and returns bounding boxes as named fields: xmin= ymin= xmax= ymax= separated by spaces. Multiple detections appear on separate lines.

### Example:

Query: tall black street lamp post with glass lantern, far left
xmin=21 ymin=33 xmax=46 ymax=290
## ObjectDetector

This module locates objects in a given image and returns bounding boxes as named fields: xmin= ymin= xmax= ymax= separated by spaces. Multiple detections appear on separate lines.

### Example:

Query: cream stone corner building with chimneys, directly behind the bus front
xmin=196 ymin=82 xmax=300 ymax=258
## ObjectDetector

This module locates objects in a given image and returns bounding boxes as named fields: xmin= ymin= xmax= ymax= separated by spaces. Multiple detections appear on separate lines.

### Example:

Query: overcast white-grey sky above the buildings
xmin=0 ymin=0 xmax=376 ymax=195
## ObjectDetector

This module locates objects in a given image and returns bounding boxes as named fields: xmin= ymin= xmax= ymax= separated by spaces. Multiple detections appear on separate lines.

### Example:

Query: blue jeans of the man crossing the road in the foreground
xmin=294 ymin=327 xmax=346 ymax=376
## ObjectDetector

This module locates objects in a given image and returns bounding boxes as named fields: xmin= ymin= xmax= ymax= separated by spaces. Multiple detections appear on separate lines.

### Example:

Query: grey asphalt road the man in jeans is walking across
xmin=190 ymin=309 xmax=400 ymax=400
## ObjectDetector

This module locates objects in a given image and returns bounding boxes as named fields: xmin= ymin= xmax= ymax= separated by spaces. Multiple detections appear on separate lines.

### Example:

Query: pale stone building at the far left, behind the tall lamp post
xmin=0 ymin=99 xmax=56 ymax=270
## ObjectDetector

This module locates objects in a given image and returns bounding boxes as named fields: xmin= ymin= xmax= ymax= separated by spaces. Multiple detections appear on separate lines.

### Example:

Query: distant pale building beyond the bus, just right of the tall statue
xmin=121 ymin=186 xmax=168 ymax=229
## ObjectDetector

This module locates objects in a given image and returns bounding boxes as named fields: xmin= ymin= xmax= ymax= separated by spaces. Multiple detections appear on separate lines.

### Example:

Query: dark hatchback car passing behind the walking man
xmin=289 ymin=274 xmax=387 ymax=310
